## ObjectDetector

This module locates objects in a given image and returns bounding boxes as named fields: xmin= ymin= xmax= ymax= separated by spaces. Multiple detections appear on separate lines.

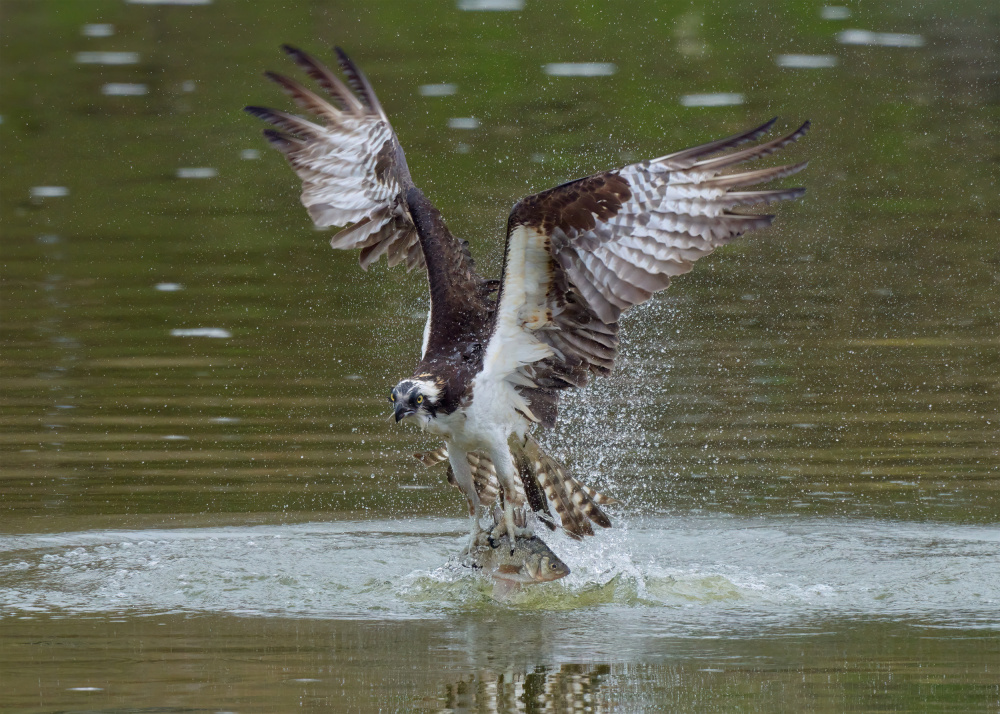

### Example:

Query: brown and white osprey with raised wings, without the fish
xmin=246 ymin=45 xmax=809 ymax=548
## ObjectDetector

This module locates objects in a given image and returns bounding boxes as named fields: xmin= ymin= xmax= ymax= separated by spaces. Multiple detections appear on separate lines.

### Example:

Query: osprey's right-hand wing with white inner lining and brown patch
xmin=484 ymin=119 xmax=809 ymax=426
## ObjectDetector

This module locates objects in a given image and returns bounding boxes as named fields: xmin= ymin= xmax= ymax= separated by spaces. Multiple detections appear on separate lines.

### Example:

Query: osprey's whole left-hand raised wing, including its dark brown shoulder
xmin=246 ymin=45 xmax=495 ymax=370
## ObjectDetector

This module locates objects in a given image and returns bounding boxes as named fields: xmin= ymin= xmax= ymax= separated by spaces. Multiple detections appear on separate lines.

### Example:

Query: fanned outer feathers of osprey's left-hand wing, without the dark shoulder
xmin=246 ymin=45 xmax=424 ymax=270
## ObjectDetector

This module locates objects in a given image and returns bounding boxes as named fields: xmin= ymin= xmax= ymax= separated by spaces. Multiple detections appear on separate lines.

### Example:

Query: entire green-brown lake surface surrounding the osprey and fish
xmin=0 ymin=0 xmax=1000 ymax=712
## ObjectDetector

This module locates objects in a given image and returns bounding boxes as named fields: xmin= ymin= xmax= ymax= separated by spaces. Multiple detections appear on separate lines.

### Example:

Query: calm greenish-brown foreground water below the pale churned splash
xmin=0 ymin=614 xmax=1000 ymax=714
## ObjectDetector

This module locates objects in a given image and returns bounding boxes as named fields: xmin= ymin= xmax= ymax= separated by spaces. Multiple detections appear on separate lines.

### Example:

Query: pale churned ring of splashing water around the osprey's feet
xmin=0 ymin=516 xmax=1000 ymax=631
